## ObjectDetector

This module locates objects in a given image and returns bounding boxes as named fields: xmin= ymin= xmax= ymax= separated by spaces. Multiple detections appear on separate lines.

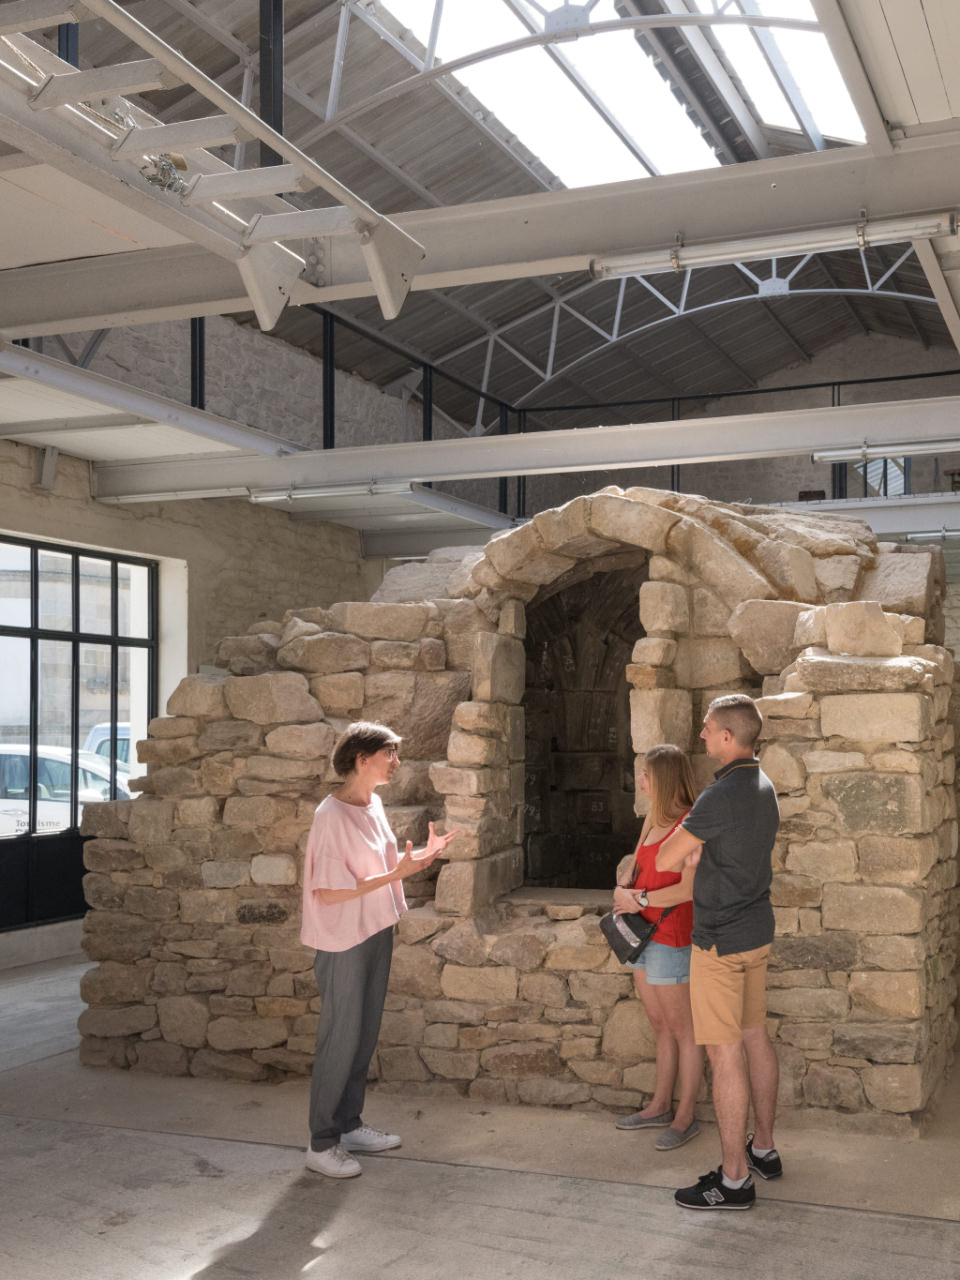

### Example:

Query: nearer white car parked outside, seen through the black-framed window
xmin=0 ymin=742 xmax=131 ymax=837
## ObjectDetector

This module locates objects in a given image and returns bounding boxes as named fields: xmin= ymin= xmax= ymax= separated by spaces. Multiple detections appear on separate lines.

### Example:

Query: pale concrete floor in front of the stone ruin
xmin=0 ymin=961 xmax=960 ymax=1280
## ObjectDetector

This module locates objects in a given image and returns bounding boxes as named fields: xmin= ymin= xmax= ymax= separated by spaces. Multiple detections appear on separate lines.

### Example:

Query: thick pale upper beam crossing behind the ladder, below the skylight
xmin=0 ymin=129 xmax=960 ymax=337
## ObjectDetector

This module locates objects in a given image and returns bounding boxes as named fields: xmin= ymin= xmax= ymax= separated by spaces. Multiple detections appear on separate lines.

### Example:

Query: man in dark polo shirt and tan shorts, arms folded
xmin=657 ymin=694 xmax=783 ymax=1208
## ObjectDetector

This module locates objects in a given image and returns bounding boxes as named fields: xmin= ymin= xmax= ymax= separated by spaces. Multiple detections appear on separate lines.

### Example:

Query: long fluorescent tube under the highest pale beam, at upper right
xmin=590 ymin=212 xmax=956 ymax=280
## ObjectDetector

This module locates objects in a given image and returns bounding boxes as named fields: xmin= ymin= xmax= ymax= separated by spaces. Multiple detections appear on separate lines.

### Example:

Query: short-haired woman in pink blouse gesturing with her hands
xmin=301 ymin=721 xmax=457 ymax=1178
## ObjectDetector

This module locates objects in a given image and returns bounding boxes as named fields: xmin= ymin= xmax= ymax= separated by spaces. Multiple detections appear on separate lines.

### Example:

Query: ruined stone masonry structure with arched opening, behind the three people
xmin=81 ymin=488 xmax=960 ymax=1134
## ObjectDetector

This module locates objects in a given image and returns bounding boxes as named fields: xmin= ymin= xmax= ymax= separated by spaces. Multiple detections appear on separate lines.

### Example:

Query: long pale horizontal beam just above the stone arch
xmin=95 ymin=396 xmax=960 ymax=502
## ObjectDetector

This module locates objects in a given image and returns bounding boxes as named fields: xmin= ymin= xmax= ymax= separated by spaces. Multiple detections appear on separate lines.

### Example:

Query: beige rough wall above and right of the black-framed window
xmin=0 ymin=440 xmax=381 ymax=682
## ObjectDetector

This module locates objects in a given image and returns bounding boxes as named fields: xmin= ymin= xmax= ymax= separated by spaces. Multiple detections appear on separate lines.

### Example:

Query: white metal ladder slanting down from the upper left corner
xmin=0 ymin=0 xmax=425 ymax=329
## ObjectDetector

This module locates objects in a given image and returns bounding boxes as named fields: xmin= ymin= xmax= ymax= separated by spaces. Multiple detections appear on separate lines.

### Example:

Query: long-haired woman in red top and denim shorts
xmin=613 ymin=744 xmax=704 ymax=1151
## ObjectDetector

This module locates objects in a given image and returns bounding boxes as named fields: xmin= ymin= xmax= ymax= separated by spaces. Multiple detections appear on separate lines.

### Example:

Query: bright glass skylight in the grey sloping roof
xmin=383 ymin=0 xmax=864 ymax=187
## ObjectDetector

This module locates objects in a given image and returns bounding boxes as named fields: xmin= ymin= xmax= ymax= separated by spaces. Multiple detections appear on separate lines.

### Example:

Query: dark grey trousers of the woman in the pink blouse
xmin=310 ymin=925 xmax=393 ymax=1151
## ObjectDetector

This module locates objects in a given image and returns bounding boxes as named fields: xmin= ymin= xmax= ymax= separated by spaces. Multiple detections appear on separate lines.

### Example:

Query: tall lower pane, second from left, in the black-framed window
xmin=37 ymin=637 xmax=73 ymax=832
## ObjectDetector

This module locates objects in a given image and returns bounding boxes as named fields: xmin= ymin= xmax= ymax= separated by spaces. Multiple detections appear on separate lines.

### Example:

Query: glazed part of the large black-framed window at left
xmin=0 ymin=536 xmax=157 ymax=841
